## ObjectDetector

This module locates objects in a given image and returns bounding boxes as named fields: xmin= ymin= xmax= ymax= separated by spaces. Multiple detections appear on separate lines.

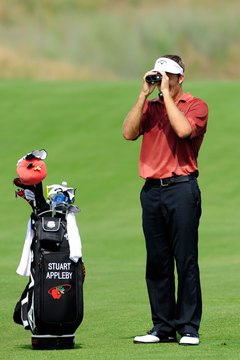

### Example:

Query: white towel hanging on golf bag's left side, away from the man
xmin=17 ymin=219 xmax=34 ymax=276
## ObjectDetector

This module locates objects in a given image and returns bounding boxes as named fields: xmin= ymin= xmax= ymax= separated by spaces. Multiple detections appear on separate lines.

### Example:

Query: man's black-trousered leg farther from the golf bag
xmin=164 ymin=180 xmax=202 ymax=335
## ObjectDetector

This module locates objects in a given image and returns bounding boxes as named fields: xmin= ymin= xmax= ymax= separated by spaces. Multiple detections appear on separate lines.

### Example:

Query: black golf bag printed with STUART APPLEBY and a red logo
xmin=13 ymin=153 xmax=85 ymax=349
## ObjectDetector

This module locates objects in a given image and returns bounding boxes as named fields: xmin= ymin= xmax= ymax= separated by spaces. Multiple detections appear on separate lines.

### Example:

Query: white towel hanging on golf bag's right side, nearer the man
xmin=67 ymin=212 xmax=82 ymax=262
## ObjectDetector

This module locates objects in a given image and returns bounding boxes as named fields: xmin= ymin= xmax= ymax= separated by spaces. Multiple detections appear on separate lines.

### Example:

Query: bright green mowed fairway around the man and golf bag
xmin=0 ymin=81 xmax=240 ymax=360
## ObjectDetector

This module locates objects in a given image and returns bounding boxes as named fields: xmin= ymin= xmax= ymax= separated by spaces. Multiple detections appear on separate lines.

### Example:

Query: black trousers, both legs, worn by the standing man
xmin=141 ymin=178 xmax=202 ymax=335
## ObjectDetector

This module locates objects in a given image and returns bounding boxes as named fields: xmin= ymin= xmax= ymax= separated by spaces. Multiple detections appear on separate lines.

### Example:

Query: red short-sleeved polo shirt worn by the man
xmin=139 ymin=93 xmax=208 ymax=179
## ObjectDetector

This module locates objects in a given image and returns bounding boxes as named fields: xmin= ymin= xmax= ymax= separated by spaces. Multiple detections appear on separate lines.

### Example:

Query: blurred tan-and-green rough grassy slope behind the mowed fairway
xmin=0 ymin=0 xmax=240 ymax=80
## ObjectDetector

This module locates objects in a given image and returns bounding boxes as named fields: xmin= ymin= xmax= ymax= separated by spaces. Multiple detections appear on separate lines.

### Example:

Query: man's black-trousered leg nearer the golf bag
xmin=141 ymin=185 xmax=176 ymax=335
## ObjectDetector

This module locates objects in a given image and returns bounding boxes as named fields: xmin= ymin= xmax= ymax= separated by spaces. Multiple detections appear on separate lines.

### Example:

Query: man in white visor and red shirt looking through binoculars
xmin=123 ymin=55 xmax=208 ymax=345
